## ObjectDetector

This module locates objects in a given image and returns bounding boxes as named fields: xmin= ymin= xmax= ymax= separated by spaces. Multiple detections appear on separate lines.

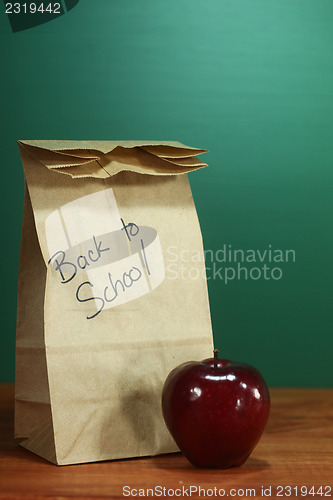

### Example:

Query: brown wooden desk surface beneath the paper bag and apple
xmin=0 ymin=385 xmax=333 ymax=500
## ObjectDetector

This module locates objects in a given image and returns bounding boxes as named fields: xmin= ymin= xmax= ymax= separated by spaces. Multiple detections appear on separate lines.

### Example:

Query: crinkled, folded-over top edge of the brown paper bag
xmin=19 ymin=141 xmax=207 ymax=179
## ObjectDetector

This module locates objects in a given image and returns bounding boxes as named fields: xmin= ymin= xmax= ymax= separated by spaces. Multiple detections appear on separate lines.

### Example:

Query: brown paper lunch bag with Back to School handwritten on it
xmin=15 ymin=141 xmax=213 ymax=465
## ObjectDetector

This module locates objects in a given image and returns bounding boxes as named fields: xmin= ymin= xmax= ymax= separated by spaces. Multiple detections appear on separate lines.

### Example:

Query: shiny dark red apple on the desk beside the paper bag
xmin=162 ymin=349 xmax=270 ymax=469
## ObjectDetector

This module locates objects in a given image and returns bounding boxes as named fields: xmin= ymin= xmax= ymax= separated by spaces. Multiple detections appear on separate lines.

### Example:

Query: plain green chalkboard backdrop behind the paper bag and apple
xmin=0 ymin=0 xmax=333 ymax=386
